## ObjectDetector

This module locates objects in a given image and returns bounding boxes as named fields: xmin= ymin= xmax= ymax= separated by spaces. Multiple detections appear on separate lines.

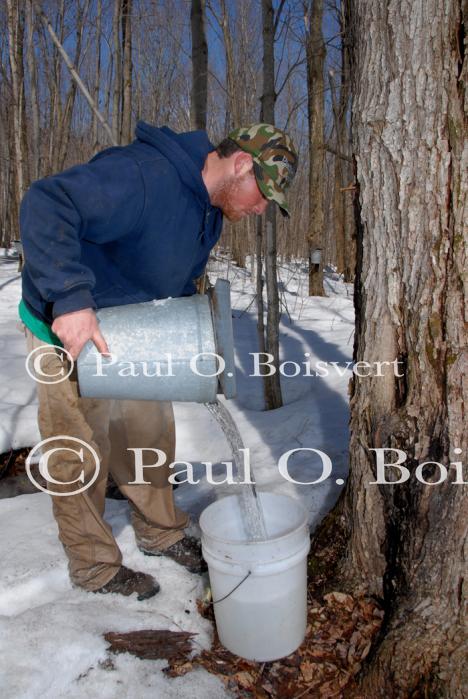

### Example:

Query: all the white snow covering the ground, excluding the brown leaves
xmin=0 ymin=251 xmax=354 ymax=699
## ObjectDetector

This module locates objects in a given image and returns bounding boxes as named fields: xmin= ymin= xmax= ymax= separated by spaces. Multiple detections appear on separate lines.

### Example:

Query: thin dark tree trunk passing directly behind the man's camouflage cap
xmin=260 ymin=0 xmax=283 ymax=410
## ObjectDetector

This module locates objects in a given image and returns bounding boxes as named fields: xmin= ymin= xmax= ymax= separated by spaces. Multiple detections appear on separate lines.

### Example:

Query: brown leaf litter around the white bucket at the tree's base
xmin=165 ymin=591 xmax=383 ymax=699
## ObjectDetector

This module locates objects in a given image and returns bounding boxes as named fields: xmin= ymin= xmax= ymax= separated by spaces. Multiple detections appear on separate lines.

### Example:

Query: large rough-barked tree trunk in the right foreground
xmin=320 ymin=0 xmax=468 ymax=699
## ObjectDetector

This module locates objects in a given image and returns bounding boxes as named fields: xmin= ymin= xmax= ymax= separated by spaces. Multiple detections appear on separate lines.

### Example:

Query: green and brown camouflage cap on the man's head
xmin=228 ymin=124 xmax=297 ymax=216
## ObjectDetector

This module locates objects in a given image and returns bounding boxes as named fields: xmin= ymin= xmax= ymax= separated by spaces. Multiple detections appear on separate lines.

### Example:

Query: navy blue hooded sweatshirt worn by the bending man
xmin=20 ymin=122 xmax=222 ymax=324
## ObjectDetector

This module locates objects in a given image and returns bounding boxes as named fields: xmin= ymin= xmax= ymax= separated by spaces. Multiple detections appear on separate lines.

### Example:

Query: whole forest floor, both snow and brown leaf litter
xmin=0 ymin=256 xmax=381 ymax=699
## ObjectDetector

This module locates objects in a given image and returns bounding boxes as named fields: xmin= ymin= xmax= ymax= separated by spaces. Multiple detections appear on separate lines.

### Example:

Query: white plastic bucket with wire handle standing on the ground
xmin=200 ymin=493 xmax=310 ymax=662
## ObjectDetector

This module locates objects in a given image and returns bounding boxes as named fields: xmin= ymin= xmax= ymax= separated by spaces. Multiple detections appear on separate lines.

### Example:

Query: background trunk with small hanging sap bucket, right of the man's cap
xmin=306 ymin=0 xmax=326 ymax=296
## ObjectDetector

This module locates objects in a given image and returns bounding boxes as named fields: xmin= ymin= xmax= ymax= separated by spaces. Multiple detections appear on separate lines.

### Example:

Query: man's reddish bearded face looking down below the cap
xmin=214 ymin=171 xmax=268 ymax=223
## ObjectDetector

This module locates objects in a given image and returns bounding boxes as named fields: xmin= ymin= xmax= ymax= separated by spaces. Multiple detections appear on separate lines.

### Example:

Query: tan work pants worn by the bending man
xmin=25 ymin=329 xmax=188 ymax=590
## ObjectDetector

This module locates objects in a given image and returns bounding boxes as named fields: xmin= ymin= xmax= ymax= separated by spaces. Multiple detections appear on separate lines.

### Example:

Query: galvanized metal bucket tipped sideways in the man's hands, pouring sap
xmin=77 ymin=279 xmax=236 ymax=403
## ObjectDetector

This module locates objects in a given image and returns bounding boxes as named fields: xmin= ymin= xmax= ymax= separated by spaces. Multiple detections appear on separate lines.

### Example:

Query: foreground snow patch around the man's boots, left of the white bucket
xmin=0 ymin=493 xmax=227 ymax=699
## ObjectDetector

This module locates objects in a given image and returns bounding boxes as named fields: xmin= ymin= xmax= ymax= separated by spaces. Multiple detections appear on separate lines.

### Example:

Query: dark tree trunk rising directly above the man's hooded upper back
xmin=190 ymin=0 xmax=208 ymax=129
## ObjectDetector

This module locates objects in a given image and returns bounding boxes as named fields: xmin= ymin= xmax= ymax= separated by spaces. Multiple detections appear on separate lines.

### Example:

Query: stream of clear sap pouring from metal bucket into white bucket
xmin=205 ymin=401 xmax=268 ymax=541
